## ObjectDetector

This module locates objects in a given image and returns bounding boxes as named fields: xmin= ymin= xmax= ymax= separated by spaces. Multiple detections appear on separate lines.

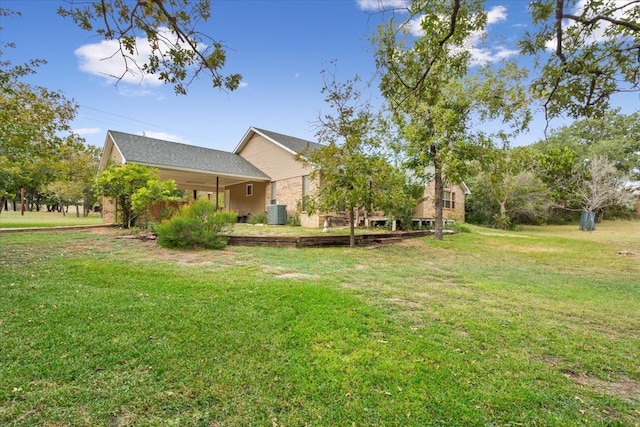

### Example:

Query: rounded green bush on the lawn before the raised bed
xmin=156 ymin=200 xmax=237 ymax=249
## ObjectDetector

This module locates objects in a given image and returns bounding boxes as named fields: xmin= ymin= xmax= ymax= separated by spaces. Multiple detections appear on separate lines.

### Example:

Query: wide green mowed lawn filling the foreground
xmin=0 ymin=222 xmax=640 ymax=427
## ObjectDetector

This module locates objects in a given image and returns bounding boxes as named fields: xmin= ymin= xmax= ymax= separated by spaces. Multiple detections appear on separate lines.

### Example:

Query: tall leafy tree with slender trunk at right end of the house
xmin=375 ymin=0 xmax=529 ymax=240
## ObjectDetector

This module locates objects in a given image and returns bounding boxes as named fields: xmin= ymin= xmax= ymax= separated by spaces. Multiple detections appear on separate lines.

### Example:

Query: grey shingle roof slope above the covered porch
xmin=109 ymin=130 xmax=269 ymax=179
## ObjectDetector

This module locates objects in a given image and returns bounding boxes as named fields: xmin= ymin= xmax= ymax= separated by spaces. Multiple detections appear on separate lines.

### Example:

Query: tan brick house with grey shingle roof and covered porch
xmin=99 ymin=127 xmax=469 ymax=227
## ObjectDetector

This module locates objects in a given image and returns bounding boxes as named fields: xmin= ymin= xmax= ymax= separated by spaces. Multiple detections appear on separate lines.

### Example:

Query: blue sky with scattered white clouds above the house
xmin=0 ymin=0 xmax=639 ymax=151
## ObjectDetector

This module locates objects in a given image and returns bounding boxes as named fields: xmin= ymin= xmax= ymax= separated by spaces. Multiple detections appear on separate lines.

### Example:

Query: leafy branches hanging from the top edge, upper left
xmin=58 ymin=0 xmax=242 ymax=94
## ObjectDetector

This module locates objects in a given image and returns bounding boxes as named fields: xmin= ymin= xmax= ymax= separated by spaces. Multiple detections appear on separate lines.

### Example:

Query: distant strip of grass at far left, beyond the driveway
xmin=0 ymin=207 xmax=102 ymax=228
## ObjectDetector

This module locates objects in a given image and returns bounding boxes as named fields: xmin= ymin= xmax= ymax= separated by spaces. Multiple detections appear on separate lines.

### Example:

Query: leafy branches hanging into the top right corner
xmin=520 ymin=0 xmax=640 ymax=120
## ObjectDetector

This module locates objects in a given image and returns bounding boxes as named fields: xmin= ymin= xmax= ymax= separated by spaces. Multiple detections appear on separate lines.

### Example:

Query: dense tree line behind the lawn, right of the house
xmin=466 ymin=112 xmax=640 ymax=228
